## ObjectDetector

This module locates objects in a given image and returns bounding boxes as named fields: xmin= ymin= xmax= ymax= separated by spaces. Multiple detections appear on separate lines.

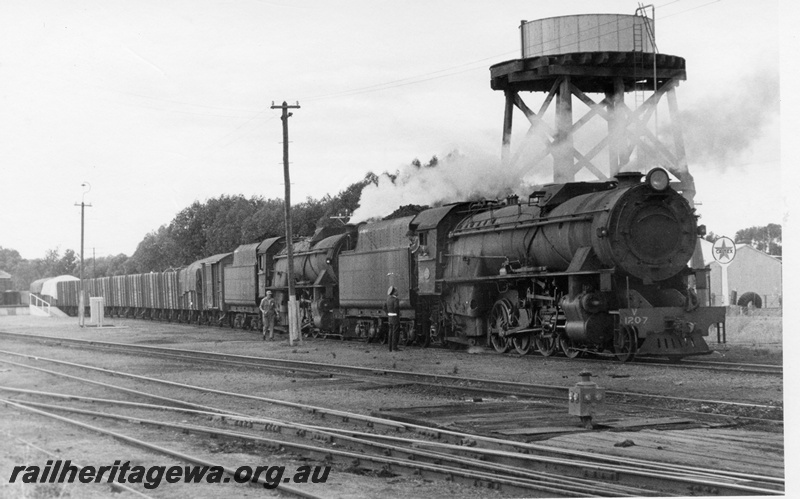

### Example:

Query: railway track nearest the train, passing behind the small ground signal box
xmin=0 ymin=332 xmax=783 ymax=425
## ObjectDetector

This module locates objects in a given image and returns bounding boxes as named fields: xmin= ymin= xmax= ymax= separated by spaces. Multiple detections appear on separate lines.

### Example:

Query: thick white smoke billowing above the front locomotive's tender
xmin=350 ymin=151 xmax=530 ymax=223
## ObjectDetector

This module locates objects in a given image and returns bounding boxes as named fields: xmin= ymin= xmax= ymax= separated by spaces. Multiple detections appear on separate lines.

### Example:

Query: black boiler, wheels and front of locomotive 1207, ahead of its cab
xmin=439 ymin=168 xmax=724 ymax=360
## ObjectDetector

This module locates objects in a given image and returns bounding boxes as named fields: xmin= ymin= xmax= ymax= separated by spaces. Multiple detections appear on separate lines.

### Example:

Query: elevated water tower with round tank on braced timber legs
xmin=491 ymin=7 xmax=695 ymax=203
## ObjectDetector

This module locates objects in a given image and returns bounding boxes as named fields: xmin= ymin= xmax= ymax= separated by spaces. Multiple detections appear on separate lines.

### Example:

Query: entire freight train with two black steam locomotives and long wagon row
xmin=51 ymin=168 xmax=725 ymax=361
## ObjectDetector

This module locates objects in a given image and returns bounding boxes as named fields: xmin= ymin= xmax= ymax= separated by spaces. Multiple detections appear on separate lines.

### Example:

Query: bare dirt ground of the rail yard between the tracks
xmin=0 ymin=316 xmax=795 ymax=498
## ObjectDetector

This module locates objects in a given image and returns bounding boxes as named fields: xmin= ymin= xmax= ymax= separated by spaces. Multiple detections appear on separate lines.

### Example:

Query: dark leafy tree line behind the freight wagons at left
xmin=0 ymin=172 xmax=378 ymax=290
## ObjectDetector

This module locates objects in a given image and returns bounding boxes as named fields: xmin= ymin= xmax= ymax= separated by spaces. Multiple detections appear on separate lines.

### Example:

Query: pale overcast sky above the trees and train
xmin=0 ymin=0 xmax=786 ymax=259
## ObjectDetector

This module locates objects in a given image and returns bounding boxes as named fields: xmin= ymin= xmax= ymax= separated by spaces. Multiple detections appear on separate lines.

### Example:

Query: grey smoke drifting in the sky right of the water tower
xmin=681 ymin=68 xmax=780 ymax=170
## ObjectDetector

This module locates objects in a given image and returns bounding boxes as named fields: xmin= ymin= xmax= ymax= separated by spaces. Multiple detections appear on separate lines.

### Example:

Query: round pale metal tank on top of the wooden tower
xmin=520 ymin=14 xmax=655 ymax=59
